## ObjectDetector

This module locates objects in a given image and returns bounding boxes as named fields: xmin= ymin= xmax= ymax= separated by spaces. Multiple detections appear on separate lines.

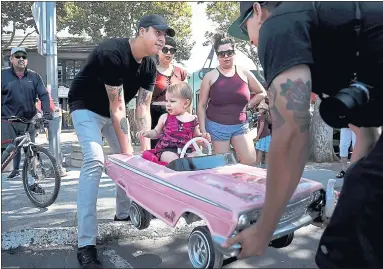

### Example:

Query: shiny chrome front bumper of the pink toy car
xmin=213 ymin=209 xmax=320 ymax=257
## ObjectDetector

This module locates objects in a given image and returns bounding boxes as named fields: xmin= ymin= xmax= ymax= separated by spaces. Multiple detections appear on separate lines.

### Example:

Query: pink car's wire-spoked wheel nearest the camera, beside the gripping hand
xmin=188 ymin=226 xmax=223 ymax=268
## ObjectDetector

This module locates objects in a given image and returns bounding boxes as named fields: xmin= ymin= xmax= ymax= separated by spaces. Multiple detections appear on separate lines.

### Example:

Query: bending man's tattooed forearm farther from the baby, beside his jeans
xmin=105 ymin=85 xmax=133 ymax=153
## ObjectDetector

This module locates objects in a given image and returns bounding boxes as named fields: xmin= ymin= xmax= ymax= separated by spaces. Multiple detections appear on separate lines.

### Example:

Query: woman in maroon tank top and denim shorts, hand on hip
xmin=197 ymin=33 xmax=266 ymax=165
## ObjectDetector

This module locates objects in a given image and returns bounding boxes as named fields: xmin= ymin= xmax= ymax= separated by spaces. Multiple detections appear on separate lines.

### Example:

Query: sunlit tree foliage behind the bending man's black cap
xmin=58 ymin=1 xmax=194 ymax=61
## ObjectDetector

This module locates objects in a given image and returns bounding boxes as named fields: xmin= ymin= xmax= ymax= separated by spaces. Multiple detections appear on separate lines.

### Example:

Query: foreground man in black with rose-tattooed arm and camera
xmin=224 ymin=1 xmax=383 ymax=268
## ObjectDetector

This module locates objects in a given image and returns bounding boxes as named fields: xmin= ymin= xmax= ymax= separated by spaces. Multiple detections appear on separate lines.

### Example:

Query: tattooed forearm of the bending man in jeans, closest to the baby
xmin=136 ymin=88 xmax=152 ymax=150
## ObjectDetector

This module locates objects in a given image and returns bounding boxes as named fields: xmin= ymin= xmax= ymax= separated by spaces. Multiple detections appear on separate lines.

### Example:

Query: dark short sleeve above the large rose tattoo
xmin=258 ymin=12 xmax=314 ymax=88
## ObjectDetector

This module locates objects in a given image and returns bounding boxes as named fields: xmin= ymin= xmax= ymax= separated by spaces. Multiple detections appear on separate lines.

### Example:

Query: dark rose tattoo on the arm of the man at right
xmin=280 ymin=78 xmax=311 ymax=133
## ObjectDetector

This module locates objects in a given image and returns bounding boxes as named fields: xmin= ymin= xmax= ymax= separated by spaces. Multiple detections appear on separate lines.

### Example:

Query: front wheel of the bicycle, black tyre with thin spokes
xmin=22 ymin=145 xmax=61 ymax=208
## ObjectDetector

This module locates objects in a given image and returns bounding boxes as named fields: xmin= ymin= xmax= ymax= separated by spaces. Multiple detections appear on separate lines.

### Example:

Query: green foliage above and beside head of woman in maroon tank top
xmin=204 ymin=2 xmax=260 ymax=74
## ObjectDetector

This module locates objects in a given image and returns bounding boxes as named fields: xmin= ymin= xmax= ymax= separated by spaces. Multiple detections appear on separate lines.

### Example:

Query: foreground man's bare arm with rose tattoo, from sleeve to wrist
xmin=257 ymin=65 xmax=311 ymax=236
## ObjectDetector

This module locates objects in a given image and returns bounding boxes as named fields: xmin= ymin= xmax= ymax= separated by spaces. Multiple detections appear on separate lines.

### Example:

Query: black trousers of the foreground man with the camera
xmin=315 ymin=132 xmax=383 ymax=268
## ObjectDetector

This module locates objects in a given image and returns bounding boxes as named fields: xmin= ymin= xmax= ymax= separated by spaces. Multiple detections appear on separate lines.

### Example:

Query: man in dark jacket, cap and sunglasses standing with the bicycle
xmin=1 ymin=47 xmax=52 ymax=188
